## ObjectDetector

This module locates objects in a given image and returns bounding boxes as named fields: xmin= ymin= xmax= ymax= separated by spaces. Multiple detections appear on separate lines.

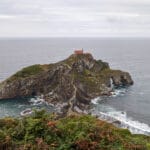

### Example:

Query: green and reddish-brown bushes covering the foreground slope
xmin=0 ymin=110 xmax=150 ymax=150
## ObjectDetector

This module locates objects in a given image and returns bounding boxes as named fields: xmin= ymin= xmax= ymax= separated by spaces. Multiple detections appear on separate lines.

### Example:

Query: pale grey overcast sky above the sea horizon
xmin=0 ymin=0 xmax=150 ymax=37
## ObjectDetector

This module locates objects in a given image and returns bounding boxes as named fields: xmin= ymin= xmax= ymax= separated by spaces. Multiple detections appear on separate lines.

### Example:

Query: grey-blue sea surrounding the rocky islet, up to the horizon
xmin=0 ymin=37 xmax=150 ymax=135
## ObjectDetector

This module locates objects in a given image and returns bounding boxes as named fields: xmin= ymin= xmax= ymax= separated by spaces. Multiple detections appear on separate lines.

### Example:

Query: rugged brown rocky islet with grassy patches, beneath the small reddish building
xmin=0 ymin=54 xmax=133 ymax=113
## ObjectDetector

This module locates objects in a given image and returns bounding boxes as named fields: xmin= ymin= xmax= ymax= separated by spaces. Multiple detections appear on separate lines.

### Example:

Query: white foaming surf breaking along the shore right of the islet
xmin=91 ymin=89 xmax=150 ymax=135
